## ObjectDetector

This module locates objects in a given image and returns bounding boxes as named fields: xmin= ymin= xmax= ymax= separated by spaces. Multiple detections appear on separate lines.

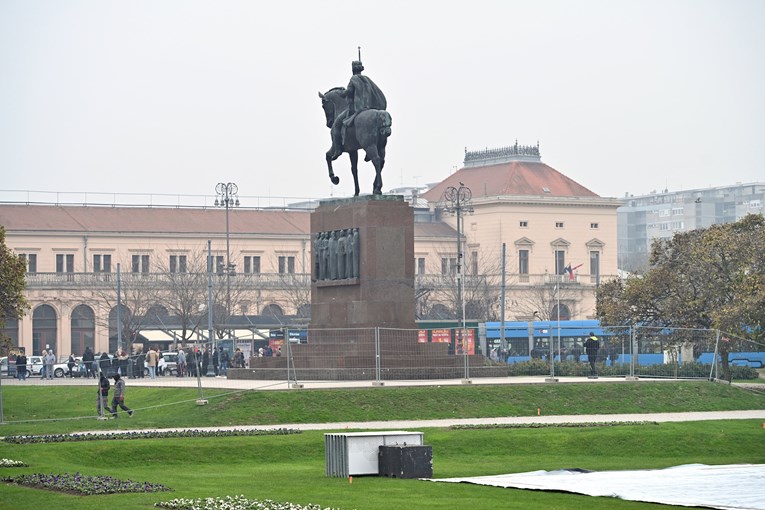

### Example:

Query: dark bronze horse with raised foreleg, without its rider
xmin=319 ymin=87 xmax=391 ymax=197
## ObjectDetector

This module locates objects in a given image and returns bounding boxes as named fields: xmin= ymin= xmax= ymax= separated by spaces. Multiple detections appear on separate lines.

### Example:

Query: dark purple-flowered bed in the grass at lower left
xmin=1 ymin=473 xmax=172 ymax=496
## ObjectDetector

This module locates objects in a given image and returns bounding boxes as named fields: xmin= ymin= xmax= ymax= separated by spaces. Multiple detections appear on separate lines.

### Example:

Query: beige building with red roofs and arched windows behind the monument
xmin=0 ymin=145 xmax=620 ymax=356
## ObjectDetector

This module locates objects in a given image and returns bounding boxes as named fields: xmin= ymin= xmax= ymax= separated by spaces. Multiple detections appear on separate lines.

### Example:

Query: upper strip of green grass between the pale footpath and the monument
xmin=0 ymin=381 xmax=765 ymax=435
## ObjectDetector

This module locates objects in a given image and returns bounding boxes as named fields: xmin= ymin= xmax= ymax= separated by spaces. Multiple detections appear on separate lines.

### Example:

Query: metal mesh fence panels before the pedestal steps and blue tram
xmin=237 ymin=324 xmax=765 ymax=382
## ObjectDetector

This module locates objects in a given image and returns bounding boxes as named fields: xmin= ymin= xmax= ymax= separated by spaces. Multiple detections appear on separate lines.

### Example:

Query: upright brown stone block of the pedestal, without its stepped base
xmin=311 ymin=195 xmax=415 ymax=329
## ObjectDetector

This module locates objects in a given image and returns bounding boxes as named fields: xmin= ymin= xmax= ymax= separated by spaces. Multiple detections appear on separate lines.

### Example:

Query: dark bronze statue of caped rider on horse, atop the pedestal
xmin=319 ymin=60 xmax=392 ymax=196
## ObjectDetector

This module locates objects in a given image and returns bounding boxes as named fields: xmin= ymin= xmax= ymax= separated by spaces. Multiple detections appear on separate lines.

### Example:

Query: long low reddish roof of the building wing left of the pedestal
xmin=0 ymin=204 xmax=311 ymax=235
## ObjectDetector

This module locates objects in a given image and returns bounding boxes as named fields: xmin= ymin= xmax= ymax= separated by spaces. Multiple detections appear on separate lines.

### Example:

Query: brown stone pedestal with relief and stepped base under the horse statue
xmin=219 ymin=195 xmax=496 ymax=385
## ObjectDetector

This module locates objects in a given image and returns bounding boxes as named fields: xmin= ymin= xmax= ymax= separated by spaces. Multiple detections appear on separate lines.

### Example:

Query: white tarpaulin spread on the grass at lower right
xmin=432 ymin=464 xmax=765 ymax=510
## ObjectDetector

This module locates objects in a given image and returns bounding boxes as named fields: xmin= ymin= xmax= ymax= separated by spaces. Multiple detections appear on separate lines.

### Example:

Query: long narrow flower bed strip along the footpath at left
xmin=3 ymin=429 xmax=301 ymax=444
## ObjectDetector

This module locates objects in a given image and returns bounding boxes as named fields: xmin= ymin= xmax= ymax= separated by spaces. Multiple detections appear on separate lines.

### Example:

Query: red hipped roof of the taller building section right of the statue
xmin=422 ymin=161 xmax=598 ymax=202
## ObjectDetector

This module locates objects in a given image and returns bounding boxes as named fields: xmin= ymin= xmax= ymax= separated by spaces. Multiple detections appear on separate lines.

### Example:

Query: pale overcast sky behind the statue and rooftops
xmin=0 ymin=0 xmax=765 ymax=205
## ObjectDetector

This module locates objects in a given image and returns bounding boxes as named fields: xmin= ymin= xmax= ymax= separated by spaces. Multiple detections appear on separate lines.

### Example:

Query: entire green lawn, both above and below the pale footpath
xmin=0 ymin=382 xmax=765 ymax=510
